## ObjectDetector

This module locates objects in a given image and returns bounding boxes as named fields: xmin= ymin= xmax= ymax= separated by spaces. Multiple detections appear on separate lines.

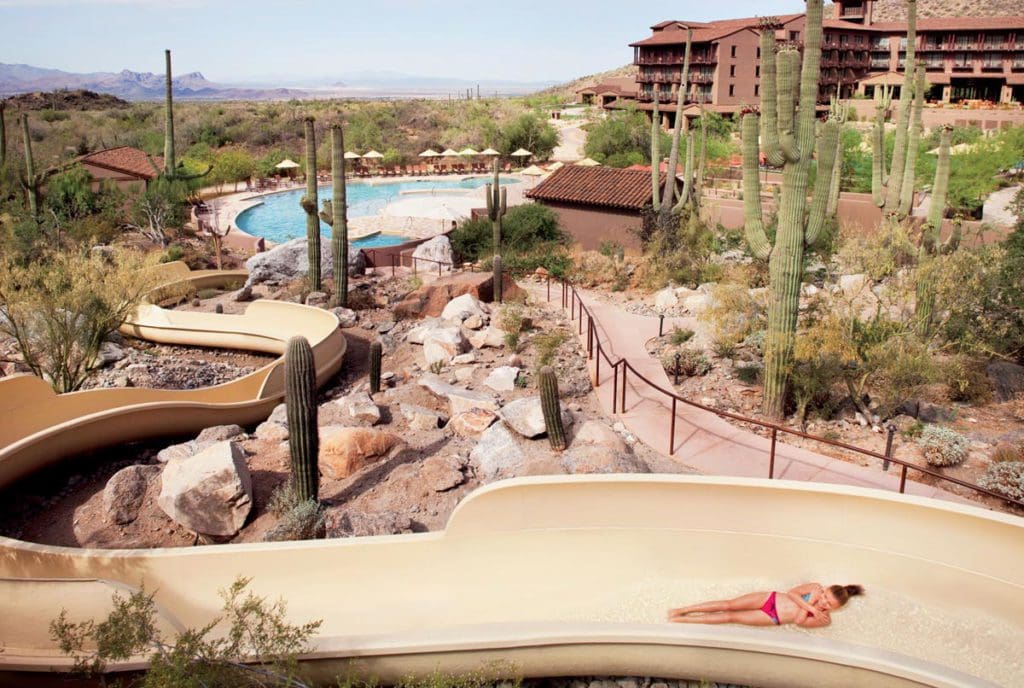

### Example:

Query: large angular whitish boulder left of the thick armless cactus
xmin=157 ymin=441 xmax=253 ymax=538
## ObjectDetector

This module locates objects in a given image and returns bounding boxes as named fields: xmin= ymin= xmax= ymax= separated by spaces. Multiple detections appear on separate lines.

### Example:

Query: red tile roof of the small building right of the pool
xmin=526 ymin=165 xmax=651 ymax=210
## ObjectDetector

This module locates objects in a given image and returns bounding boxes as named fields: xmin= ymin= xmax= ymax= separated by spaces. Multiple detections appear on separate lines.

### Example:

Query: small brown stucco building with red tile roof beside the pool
xmin=526 ymin=165 xmax=651 ymax=251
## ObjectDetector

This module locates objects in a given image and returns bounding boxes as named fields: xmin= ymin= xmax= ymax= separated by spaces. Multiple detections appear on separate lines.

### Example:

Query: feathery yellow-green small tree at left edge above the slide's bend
xmin=0 ymin=245 xmax=157 ymax=393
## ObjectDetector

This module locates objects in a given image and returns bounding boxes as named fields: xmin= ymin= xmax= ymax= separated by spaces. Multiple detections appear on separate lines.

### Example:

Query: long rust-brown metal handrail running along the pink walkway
xmin=548 ymin=276 xmax=1024 ymax=509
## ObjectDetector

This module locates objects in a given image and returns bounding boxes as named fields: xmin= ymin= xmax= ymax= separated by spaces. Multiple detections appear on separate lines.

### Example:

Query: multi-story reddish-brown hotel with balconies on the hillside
xmin=604 ymin=0 xmax=1024 ymax=126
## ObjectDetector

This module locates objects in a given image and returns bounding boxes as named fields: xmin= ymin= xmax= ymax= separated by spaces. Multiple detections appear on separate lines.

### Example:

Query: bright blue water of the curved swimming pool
xmin=236 ymin=177 xmax=517 ymax=247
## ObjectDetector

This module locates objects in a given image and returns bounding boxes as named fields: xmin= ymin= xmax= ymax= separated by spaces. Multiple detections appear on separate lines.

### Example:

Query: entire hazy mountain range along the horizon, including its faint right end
xmin=0 ymin=62 xmax=554 ymax=100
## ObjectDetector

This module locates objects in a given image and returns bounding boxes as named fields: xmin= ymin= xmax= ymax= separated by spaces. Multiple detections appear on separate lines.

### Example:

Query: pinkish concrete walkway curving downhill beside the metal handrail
xmin=524 ymin=283 xmax=977 ymax=506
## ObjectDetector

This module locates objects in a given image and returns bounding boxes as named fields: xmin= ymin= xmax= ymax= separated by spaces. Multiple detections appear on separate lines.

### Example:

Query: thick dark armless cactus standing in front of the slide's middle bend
xmin=285 ymin=337 xmax=319 ymax=501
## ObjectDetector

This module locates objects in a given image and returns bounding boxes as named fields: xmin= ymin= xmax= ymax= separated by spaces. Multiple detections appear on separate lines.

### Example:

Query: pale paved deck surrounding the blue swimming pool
xmin=204 ymin=174 xmax=537 ymax=252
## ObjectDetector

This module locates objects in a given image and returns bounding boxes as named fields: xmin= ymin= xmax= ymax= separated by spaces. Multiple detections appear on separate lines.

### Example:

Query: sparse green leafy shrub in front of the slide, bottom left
xmin=50 ymin=577 xmax=321 ymax=688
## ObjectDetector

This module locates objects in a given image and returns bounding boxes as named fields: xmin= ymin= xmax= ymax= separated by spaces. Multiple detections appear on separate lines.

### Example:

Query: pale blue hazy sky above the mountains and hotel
xmin=0 ymin=0 xmax=804 ymax=85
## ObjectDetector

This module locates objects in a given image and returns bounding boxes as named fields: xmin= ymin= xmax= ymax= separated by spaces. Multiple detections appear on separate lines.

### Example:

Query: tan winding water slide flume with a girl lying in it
xmin=0 ymin=266 xmax=1024 ymax=688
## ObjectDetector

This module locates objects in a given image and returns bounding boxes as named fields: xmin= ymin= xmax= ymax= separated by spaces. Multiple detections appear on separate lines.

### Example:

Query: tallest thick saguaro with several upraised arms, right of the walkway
xmin=742 ymin=0 xmax=840 ymax=418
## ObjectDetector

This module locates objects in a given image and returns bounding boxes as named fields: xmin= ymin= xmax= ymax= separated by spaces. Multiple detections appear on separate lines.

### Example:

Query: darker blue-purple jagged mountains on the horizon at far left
xmin=0 ymin=62 xmax=308 ymax=100
